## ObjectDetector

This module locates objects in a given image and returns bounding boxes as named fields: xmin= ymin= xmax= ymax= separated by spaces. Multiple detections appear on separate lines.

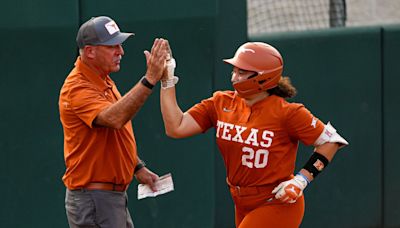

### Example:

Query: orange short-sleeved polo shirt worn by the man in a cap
xmin=59 ymin=57 xmax=137 ymax=189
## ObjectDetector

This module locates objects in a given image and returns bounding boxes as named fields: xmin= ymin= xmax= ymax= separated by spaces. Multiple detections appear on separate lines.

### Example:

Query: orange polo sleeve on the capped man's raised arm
xmin=68 ymin=84 xmax=112 ymax=128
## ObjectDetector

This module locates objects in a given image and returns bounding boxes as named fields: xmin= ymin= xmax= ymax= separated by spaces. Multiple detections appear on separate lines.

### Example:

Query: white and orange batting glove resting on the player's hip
xmin=272 ymin=174 xmax=308 ymax=203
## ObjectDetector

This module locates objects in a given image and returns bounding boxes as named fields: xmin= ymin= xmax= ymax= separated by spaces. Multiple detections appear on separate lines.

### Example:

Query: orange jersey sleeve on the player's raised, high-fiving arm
xmin=187 ymin=97 xmax=217 ymax=133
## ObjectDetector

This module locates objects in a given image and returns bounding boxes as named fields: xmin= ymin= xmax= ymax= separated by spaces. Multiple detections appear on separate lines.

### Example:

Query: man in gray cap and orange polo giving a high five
xmin=59 ymin=16 xmax=168 ymax=228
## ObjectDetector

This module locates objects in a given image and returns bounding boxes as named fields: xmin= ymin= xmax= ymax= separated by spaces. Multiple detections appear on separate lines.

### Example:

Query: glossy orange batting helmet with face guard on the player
xmin=224 ymin=42 xmax=283 ymax=97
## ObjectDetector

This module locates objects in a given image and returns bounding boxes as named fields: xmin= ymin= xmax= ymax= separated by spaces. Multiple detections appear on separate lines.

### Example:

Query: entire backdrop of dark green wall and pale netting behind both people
xmin=0 ymin=0 xmax=400 ymax=228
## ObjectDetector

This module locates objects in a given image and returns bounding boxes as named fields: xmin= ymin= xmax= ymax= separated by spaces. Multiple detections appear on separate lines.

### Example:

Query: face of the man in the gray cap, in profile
xmin=94 ymin=44 xmax=124 ymax=74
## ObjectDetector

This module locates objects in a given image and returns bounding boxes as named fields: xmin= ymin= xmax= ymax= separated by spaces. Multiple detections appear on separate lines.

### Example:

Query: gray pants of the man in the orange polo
xmin=65 ymin=189 xmax=133 ymax=228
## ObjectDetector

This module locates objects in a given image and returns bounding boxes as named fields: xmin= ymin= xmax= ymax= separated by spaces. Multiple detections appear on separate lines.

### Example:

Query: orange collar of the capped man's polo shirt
xmin=75 ymin=56 xmax=113 ymax=91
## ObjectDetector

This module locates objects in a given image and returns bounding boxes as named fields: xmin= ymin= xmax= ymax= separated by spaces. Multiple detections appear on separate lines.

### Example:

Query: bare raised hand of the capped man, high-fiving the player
xmin=144 ymin=38 xmax=169 ymax=85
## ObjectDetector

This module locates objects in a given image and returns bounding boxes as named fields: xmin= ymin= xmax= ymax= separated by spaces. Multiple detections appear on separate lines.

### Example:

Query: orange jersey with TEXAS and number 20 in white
xmin=188 ymin=91 xmax=324 ymax=186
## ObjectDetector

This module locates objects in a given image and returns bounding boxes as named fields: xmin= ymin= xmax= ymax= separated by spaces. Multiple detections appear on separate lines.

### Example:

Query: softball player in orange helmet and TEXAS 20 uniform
xmin=161 ymin=42 xmax=348 ymax=228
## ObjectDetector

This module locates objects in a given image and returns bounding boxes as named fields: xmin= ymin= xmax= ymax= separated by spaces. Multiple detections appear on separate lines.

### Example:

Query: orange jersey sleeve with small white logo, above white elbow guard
xmin=286 ymin=104 xmax=325 ymax=145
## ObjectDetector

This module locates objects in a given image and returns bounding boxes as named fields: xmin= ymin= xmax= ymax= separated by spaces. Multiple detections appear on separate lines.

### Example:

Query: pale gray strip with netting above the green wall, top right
xmin=247 ymin=0 xmax=400 ymax=36
